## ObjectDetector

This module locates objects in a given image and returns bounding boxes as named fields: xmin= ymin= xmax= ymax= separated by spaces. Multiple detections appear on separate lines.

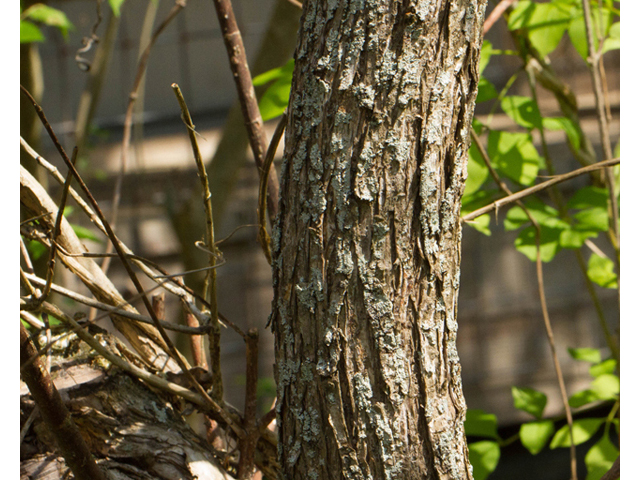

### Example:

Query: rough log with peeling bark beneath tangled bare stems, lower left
xmin=20 ymin=327 xmax=233 ymax=480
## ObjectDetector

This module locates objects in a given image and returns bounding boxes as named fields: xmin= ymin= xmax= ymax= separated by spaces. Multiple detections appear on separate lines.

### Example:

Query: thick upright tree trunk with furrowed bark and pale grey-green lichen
xmin=272 ymin=0 xmax=486 ymax=480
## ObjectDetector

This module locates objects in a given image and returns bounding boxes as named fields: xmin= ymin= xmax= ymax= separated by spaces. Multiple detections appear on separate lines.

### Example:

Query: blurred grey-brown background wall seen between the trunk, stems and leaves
xmin=21 ymin=0 xmax=620 ymax=479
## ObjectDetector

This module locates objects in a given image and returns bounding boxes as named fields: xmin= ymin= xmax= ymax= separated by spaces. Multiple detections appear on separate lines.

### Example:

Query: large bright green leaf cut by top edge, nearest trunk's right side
xmin=507 ymin=0 xmax=576 ymax=56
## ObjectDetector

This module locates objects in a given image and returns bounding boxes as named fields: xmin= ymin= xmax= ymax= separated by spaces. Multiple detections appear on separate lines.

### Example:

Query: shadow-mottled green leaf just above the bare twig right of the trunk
xmin=487 ymin=130 xmax=540 ymax=185
